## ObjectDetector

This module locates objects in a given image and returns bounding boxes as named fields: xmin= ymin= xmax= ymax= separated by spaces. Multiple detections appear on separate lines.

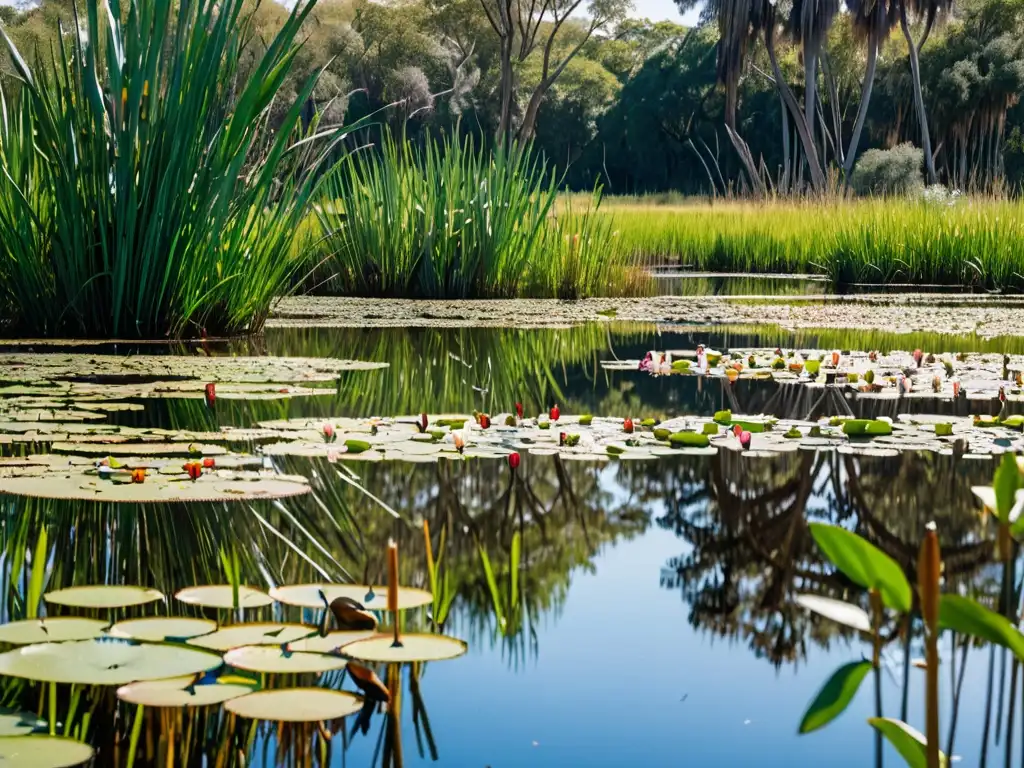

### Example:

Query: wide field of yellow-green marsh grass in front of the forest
xmin=589 ymin=198 xmax=1024 ymax=290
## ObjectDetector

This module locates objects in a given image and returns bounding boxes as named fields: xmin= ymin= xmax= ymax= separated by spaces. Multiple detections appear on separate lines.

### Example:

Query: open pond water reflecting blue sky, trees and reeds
xmin=0 ymin=325 xmax=1024 ymax=768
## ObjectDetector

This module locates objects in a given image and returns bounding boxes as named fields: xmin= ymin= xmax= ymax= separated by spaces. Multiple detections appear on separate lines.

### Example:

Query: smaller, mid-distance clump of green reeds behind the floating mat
xmin=309 ymin=134 xmax=636 ymax=298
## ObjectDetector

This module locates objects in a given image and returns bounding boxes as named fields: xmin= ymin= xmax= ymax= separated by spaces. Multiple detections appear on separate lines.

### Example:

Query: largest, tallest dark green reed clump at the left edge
xmin=0 ymin=0 xmax=348 ymax=337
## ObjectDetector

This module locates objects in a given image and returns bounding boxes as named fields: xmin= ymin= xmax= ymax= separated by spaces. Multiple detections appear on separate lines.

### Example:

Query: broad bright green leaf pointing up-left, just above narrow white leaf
xmin=810 ymin=522 xmax=911 ymax=613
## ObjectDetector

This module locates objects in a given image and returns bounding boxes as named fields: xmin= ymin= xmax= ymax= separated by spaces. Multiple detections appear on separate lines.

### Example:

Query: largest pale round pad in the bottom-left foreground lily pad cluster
xmin=0 ymin=638 xmax=221 ymax=685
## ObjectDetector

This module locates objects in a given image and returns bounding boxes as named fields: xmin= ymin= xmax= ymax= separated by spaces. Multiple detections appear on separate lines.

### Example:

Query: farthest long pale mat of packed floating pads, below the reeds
xmin=267 ymin=294 xmax=1024 ymax=338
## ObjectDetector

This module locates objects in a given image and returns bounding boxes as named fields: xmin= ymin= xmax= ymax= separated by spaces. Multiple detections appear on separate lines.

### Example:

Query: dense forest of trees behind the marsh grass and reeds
xmin=6 ymin=0 xmax=1024 ymax=195
